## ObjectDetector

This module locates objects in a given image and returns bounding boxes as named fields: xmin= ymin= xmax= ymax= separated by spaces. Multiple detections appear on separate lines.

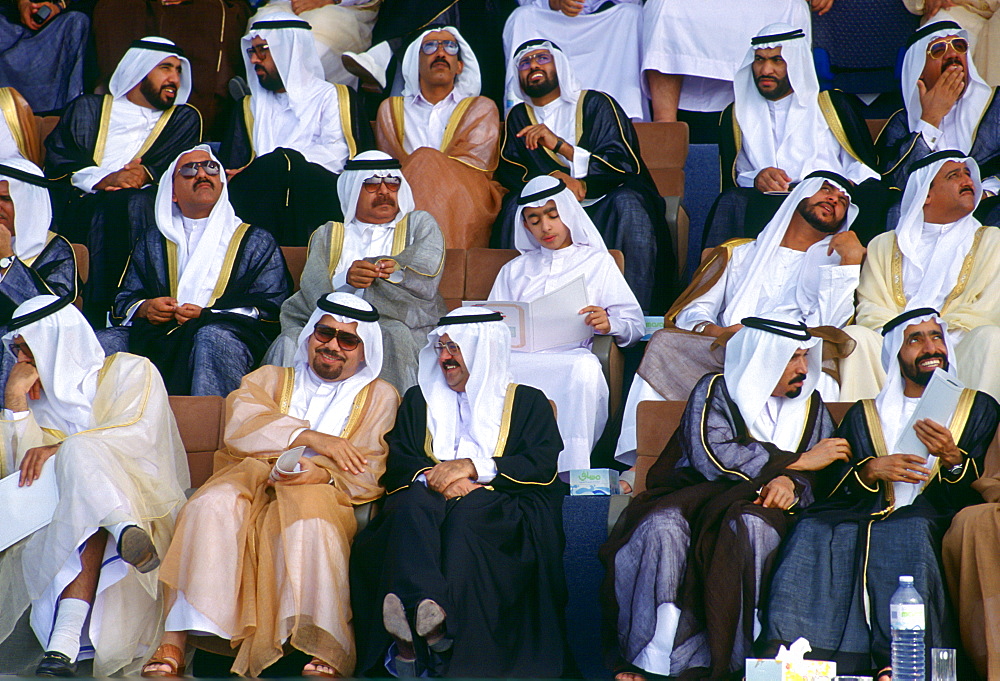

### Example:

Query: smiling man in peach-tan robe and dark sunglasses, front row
xmin=143 ymin=293 xmax=399 ymax=677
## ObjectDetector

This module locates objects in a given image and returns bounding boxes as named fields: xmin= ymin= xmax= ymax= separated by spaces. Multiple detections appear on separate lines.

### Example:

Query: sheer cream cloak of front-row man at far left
xmin=0 ymin=353 xmax=190 ymax=677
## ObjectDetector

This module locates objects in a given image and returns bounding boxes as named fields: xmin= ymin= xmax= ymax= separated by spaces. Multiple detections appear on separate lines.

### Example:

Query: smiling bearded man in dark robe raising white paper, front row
xmin=765 ymin=308 xmax=1000 ymax=674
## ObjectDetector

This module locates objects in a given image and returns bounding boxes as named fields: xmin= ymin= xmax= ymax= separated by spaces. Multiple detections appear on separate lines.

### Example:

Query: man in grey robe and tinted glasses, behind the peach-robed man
xmin=264 ymin=151 xmax=445 ymax=392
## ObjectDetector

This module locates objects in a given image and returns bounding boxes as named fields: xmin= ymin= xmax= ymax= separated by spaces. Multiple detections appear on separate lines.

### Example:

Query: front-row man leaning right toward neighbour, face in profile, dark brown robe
xmin=601 ymin=314 xmax=849 ymax=681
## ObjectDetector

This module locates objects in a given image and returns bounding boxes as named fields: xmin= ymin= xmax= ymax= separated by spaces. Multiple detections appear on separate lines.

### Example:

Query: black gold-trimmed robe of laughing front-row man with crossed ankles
xmin=351 ymin=384 xmax=567 ymax=678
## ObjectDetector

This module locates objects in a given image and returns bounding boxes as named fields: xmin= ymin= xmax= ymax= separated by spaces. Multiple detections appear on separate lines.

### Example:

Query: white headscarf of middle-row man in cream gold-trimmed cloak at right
xmin=895 ymin=150 xmax=983 ymax=308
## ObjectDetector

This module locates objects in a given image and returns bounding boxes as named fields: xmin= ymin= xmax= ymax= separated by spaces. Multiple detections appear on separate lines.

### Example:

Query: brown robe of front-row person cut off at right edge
xmin=941 ymin=440 xmax=1000 ymax=679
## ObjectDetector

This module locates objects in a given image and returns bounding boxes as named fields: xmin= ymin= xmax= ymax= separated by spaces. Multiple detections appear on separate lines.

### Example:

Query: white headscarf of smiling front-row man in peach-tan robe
xmin=288 ymin=293 xmax=382 ymax=435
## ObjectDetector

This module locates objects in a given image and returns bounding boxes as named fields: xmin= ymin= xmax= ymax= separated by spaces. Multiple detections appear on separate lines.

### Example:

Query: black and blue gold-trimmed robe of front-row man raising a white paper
xmin=764 ymin=390 xmax=1000 ymax=678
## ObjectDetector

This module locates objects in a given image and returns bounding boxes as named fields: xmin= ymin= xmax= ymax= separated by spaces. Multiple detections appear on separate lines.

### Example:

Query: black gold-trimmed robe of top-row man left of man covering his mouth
xmin=702 ymin=90 xmax=899 ymax=248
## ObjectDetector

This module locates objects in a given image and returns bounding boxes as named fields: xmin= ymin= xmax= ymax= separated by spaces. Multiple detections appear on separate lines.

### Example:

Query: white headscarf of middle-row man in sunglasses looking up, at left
xmin=156 ymin=144 xmax=242 ymax=307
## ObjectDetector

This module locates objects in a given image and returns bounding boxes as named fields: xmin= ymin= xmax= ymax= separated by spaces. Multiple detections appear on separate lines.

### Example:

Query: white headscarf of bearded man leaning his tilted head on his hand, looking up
xmin=722 ymin=171 xmax=858 ymax=326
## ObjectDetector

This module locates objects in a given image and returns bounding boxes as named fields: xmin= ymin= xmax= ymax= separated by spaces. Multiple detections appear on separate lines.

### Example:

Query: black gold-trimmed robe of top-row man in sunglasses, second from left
xmin=219 ymin=84 xmax=375 ymax=246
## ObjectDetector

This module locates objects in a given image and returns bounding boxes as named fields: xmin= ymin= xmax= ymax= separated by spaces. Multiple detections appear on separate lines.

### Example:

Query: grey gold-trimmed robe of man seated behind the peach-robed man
xmin=264 ymin=210 xmax=447 ymax=394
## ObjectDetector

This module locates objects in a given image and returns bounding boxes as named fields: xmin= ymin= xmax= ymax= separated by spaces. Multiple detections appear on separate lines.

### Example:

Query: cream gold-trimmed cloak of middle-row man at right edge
xmin=840 ymin=226 xmax=1000 ymax=402
